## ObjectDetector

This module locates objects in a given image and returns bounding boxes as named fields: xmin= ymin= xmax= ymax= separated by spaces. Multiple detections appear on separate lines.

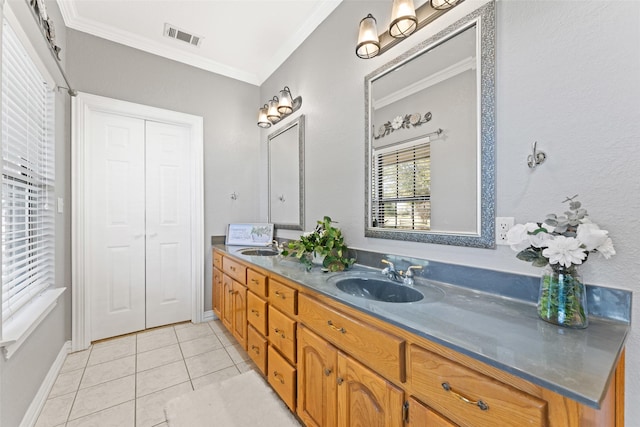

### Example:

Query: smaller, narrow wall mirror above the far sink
xmin=268 ymin=115 xmax=304 ymax=230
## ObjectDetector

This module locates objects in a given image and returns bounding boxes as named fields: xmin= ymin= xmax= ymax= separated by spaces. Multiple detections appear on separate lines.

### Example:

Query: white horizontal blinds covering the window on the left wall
xmin=2 ymin=21 xmax=54 ymax=321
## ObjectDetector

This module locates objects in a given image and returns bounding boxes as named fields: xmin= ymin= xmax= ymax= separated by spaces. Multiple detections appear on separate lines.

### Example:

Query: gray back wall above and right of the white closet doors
xmin=67 ymin=30 xmax=260 ymax=310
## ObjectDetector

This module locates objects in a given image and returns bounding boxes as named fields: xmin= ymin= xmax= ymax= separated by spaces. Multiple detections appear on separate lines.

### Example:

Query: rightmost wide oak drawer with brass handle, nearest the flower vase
xmin=409 ymin=345 xmax=547 ymax=427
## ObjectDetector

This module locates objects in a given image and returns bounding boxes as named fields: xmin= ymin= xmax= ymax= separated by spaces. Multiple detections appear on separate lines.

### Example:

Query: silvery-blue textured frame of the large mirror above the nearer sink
xmin=364 ymin=1 xmax=495 ymax=248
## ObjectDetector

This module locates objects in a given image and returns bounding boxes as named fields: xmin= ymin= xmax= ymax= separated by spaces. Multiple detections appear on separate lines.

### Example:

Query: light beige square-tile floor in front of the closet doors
xmin=36 ymin=320 xmax=257 ymax=427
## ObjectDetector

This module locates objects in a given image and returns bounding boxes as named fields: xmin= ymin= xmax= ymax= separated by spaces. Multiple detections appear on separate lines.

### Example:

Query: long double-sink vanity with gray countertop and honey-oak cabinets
xmin=213 ymin=245 xmax=629 ymax=427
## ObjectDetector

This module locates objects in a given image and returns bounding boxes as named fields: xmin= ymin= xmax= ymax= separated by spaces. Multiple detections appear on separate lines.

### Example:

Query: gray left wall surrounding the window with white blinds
xmin=0 ymin=0 xmax=71 ymax=426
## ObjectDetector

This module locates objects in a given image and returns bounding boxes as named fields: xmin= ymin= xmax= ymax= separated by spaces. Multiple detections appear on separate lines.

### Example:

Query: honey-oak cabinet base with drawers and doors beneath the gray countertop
xmin=213 ymin=253 xmax=624 ymax=427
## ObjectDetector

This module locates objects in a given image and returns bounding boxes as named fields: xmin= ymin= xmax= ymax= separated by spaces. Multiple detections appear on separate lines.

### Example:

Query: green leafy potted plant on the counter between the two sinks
xmin=282 ymin=216 xmax=356 ymax=271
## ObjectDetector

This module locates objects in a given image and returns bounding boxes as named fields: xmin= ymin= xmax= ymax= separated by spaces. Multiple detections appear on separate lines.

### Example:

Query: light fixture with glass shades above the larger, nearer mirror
xmin=356 ymin=0 xmax=464 ymax=59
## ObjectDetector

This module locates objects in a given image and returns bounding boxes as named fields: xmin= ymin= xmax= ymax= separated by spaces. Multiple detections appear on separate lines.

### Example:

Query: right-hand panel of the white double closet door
xmin=146 ymin=121 xmax=192 ymax=328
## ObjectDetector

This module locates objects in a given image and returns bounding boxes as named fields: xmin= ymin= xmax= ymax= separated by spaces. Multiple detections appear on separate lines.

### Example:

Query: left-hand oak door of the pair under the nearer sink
xmin=297 ymin=325 xmax=338 ymax=427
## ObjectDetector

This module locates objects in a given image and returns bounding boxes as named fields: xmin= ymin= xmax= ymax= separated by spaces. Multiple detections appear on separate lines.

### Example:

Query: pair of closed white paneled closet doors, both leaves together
xmin=87 ymin=112 xmax=192 ymax=340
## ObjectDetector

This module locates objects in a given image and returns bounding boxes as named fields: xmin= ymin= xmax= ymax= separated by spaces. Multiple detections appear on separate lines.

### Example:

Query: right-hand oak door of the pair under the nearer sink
xmin=336 ymin=353 xmax=404 ymax=427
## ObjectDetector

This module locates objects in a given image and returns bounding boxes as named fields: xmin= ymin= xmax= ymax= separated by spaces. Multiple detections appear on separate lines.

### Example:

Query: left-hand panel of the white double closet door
xmin=85 ymin=112 xmax=145 ymax=340
